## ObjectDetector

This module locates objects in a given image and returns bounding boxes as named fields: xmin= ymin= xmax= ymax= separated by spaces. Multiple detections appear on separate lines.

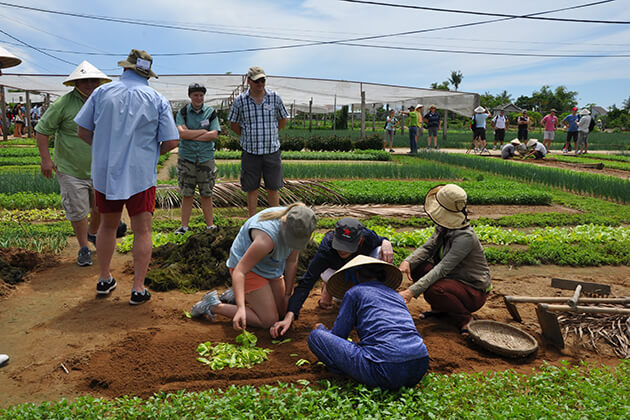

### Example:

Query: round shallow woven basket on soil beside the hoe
xmin=468 ymin=320 xmax=538 ymax=357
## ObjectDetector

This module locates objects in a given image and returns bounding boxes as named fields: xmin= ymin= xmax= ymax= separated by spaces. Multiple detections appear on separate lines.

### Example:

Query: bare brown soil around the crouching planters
xmin=0 ymin=213 xmax=630 ymax=407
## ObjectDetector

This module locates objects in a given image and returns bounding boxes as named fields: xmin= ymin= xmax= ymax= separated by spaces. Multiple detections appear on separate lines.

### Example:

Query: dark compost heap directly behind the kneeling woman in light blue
xmin=145 ymin=227 xmax=317 ymax=292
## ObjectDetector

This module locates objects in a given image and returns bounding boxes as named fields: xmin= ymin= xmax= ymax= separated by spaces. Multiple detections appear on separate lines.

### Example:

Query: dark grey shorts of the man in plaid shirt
xmin=241 ymin=150 xmax=284 ymax=192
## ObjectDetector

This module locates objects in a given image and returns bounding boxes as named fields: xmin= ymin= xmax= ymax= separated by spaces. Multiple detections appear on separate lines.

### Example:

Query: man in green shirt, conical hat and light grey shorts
xmin=35 ymin=61 xmax=111 ymax=266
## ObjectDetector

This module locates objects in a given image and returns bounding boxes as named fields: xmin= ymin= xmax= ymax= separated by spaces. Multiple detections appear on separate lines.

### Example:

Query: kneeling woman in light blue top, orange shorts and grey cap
xmin=191 ymin=203 xmax=317 ymax=330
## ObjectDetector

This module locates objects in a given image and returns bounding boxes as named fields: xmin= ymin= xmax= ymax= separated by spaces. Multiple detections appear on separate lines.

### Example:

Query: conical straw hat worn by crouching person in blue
xmin=326 ymin=255 xmax=402 ymax=299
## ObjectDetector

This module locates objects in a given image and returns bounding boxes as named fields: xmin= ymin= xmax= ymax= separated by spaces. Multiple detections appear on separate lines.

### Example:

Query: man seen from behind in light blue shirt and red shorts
xmin=74 ymin=49 xmax=179 ymax=305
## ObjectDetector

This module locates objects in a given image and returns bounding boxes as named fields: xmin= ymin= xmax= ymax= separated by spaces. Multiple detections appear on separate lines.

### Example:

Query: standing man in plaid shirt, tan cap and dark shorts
xmin=228 ymin=66 xmax=289 ymax=216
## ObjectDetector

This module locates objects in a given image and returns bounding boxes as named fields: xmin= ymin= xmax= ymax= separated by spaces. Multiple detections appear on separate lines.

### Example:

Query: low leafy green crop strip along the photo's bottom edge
xmin=0 ymin=360 xmax=630 ymax=420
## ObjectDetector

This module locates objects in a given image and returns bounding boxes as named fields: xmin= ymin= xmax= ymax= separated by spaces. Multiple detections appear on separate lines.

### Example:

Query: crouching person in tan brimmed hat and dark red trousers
xmin=400 ymin=184 xmax=492 ymax=335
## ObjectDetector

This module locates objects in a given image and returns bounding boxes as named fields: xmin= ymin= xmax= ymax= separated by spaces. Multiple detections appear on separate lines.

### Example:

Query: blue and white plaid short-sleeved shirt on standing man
xmin=228 ymin=89 xmax=289 ymax=155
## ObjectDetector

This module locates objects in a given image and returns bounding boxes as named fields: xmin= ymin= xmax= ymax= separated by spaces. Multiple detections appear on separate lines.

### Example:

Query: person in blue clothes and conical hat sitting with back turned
xmin=308 ymin=255 xmax=429 ymax=390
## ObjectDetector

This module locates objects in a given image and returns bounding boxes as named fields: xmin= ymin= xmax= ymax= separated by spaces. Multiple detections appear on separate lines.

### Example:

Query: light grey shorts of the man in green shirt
xmin=57 ymin=171 xmax=94 ymax=222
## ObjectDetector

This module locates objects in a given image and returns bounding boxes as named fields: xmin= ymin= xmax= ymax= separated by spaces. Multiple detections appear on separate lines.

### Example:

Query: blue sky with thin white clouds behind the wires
xmin=0 ymin=0 xmax=630 ymax=107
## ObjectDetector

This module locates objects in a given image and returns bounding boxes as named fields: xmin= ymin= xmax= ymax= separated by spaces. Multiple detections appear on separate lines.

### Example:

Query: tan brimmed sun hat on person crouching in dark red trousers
xmin=424 ymin=184 xmax=470 ymax=229
